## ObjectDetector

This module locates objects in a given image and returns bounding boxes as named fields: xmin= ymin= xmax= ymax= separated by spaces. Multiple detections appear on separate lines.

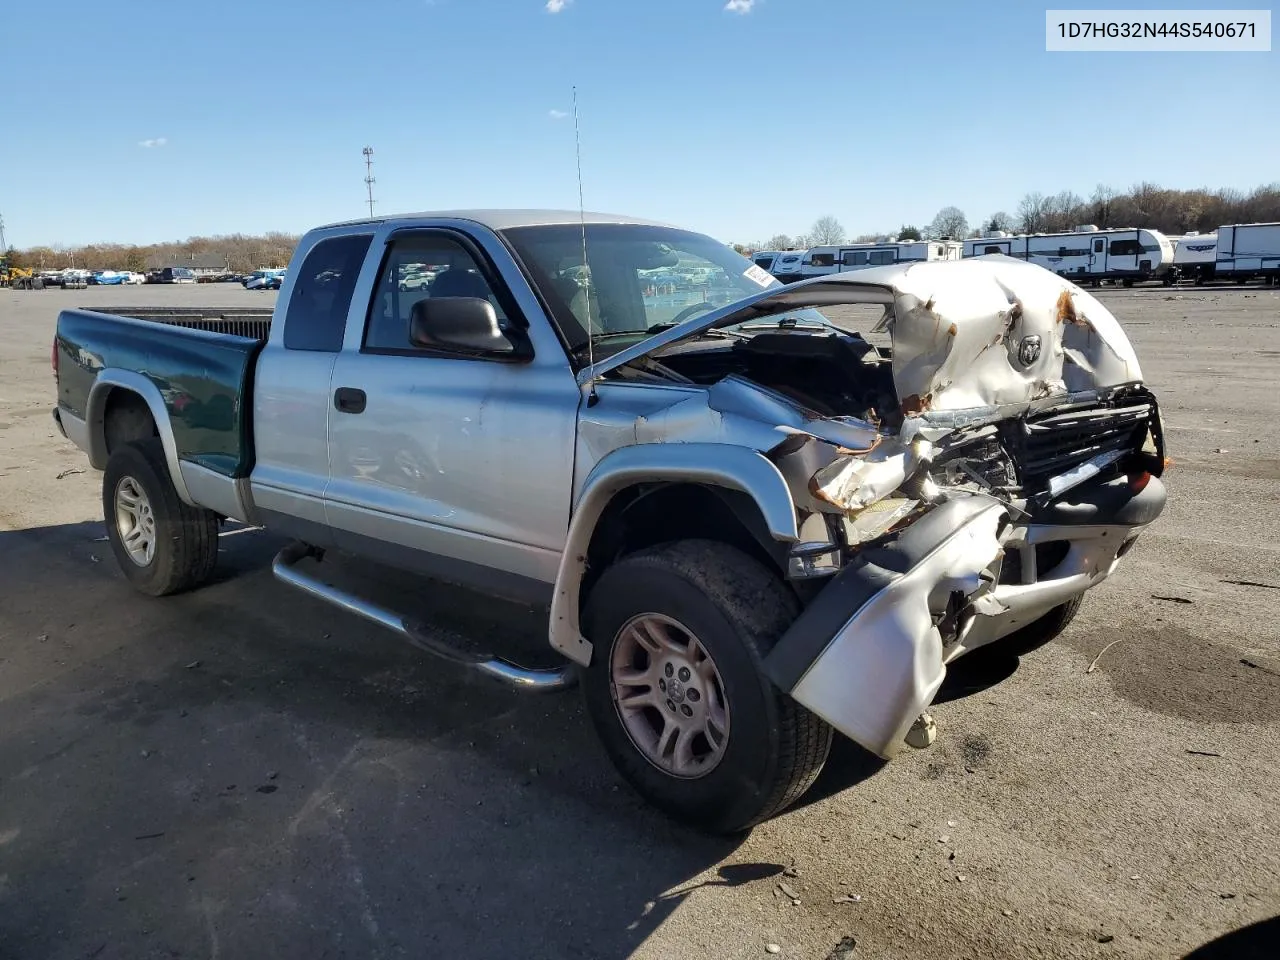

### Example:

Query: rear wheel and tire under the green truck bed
xmin=102 ymin=438 xmax=218 ymax=596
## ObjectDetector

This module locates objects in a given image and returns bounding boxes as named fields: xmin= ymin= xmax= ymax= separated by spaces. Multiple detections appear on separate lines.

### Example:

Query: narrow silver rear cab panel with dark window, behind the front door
xmin=251 ymin=234 xmax=372 ymax=547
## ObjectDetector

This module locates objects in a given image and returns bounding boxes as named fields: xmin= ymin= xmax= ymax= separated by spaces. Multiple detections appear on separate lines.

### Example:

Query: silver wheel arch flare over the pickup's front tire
xmin=549 ymin=443 xmax=800 ymax=666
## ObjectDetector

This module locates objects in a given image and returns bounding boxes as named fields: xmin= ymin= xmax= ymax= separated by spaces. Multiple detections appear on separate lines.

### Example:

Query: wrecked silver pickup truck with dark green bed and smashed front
xmin=54 ymin=211 xmax=1165 ymax=831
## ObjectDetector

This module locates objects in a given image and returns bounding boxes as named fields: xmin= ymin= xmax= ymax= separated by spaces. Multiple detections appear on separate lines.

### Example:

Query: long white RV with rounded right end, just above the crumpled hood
xmin=964 ymin=225 xmax=1174 ymax=287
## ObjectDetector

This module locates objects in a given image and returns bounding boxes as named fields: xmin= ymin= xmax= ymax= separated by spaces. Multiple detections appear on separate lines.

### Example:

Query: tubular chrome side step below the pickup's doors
xmin=271 ymin=543 xmax=575 ymax=691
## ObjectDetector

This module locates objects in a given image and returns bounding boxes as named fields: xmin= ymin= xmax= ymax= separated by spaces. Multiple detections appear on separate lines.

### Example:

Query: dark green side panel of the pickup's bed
xmin=55 ymin=307 xmax=271 ymax=479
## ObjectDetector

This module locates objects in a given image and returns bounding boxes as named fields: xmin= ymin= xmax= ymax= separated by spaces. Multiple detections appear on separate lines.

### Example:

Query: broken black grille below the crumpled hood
xmin=1001 ymin=403 xmax=1151 ymax=493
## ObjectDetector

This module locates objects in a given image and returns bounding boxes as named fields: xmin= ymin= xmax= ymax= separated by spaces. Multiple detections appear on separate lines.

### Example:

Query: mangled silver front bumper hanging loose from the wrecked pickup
xmin=764 ymin=477 xmax=1165 ymax=758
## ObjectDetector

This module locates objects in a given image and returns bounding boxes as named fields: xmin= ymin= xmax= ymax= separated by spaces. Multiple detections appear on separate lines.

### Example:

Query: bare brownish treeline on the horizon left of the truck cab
xmin=9 ymin=233 xmax=298 ymax=273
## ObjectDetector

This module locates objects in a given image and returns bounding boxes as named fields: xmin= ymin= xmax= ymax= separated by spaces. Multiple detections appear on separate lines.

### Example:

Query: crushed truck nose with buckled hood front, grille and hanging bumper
xmin=765 ymin=259 xmax=1165 ymax=758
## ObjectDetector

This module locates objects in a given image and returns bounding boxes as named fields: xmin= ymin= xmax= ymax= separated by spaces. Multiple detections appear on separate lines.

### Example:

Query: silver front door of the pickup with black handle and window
xmin=325 ymin=228 xmax=581 ymax=599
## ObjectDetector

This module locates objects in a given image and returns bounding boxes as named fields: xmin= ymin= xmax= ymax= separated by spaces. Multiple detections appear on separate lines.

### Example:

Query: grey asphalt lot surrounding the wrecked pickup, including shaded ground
xmin=0 ymin=285 xmax=1280 ymax=960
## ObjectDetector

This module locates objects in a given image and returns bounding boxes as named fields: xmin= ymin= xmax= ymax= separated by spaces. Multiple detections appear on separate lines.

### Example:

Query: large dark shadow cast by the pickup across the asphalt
xmin=0 ymin=524 xmax=781 ymax=960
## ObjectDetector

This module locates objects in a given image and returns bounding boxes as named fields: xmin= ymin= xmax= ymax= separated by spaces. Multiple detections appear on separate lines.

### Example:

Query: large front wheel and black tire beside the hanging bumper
xmin=582 ymin=540 xmax=832 ymax=833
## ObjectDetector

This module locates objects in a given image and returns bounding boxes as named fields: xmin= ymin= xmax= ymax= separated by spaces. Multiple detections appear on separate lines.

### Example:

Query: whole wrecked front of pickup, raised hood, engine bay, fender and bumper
xmin=576 ymin=257 xmax=1165 ymax=756
